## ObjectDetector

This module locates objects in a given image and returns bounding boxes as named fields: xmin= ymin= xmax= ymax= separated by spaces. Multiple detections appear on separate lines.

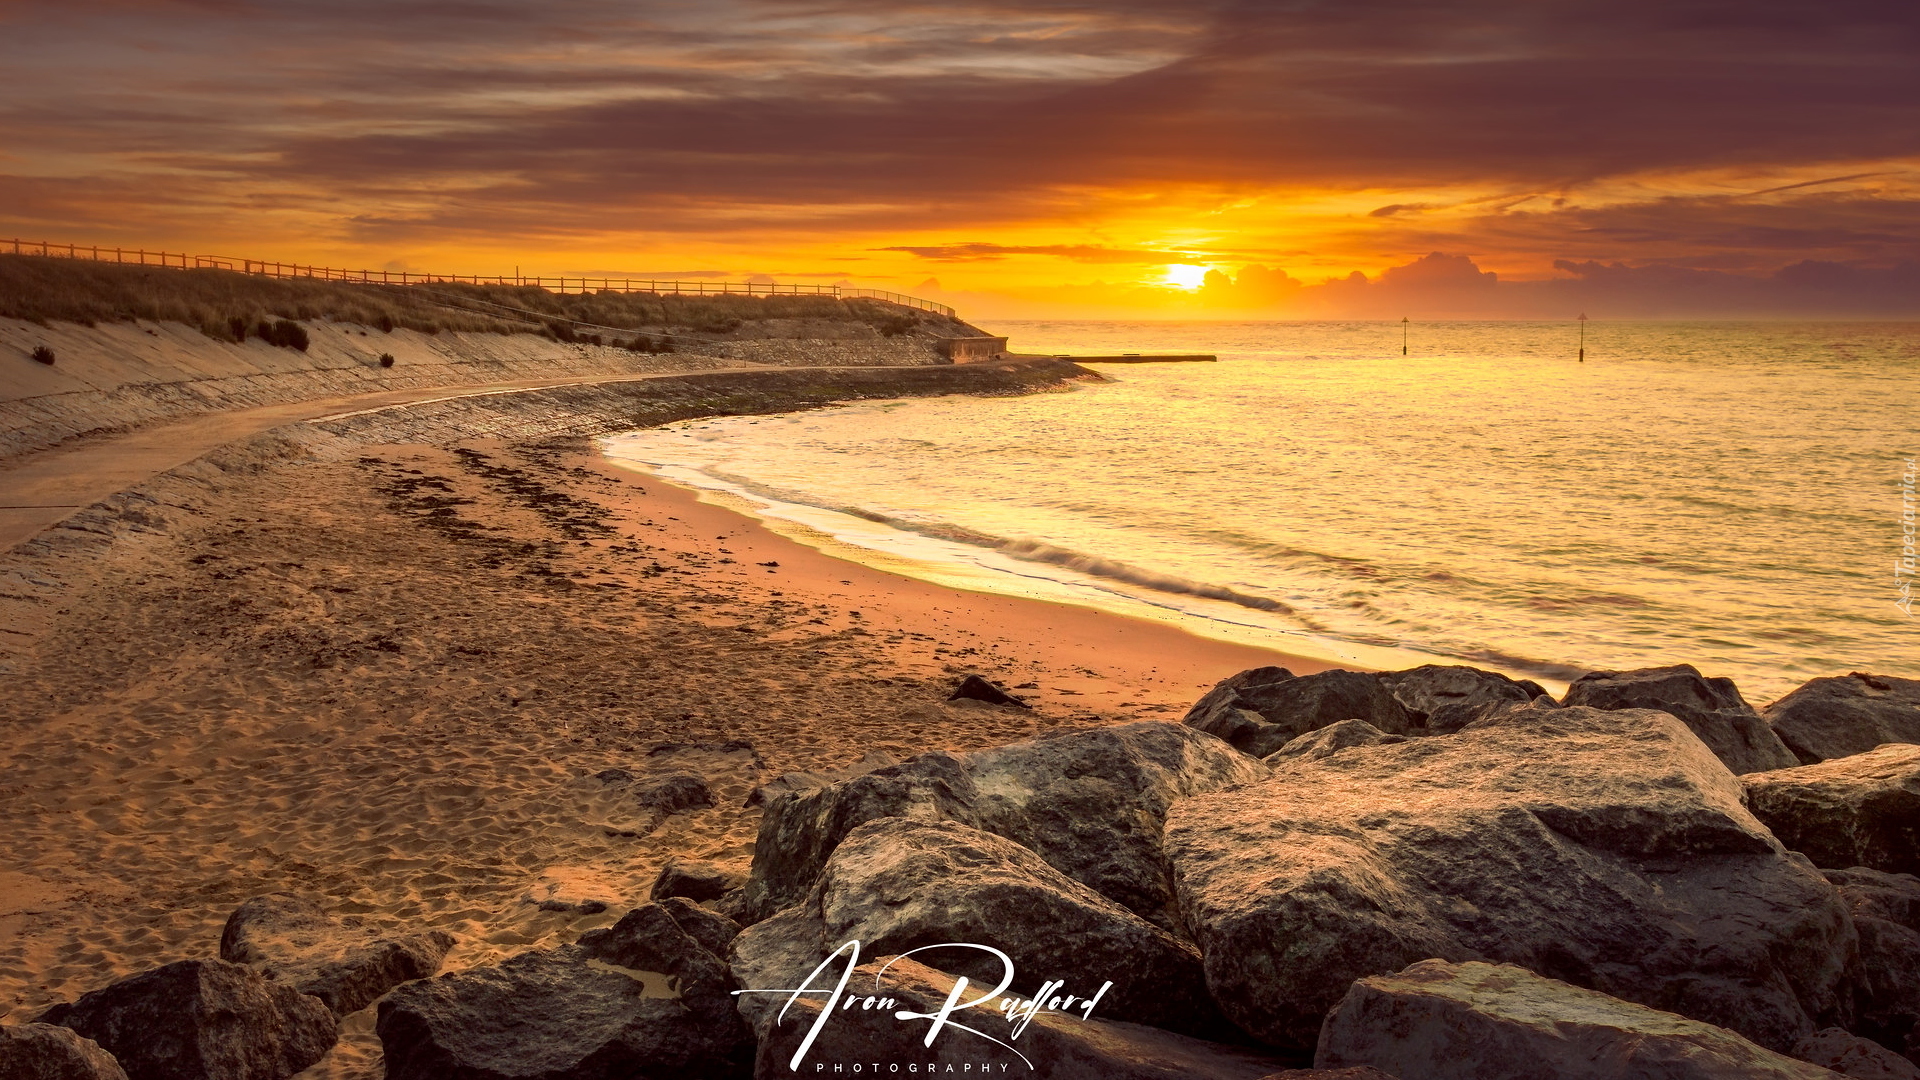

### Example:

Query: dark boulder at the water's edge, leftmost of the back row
xmin=1181 ymin=667 xmax=1423 ymax=757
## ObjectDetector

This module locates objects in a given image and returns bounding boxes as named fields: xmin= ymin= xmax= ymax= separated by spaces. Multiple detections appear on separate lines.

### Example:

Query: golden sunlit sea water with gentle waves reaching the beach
xmin=607 ymin=323 xmax=1920 ymax=705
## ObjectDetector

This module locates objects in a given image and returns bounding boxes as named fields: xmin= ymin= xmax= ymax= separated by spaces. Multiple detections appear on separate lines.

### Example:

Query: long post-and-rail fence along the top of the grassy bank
xmin=0 ymin=240 xmax=954 ymax=319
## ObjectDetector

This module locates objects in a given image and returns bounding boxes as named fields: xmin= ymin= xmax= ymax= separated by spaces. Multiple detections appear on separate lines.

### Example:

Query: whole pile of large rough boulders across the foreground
xmin=0 ymin=667 xmax=1920 ymax=1080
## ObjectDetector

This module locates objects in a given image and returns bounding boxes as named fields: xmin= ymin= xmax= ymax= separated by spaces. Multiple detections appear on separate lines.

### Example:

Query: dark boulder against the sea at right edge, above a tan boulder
xmin=1761 ymin=671 xmax=1920 ymax=765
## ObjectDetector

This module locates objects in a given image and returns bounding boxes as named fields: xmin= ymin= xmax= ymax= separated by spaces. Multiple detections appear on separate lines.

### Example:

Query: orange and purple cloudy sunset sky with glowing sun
xmin=0 ymin=0 xmax=1920 ymax=319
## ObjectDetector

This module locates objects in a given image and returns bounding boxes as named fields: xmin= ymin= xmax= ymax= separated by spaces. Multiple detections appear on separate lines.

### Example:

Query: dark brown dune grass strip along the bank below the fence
xmin=0 ymin=256 xmax=964 ymax=348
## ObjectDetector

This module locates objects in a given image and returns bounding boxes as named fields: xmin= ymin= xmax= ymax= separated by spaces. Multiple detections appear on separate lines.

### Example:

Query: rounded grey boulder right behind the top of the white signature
xmin=820 ymin=819 xmax=1233 ymax=1038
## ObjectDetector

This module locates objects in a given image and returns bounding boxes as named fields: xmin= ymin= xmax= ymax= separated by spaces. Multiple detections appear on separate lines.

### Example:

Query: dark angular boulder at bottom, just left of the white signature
xmin=376 ymin=903 xmax=753 ymax=1080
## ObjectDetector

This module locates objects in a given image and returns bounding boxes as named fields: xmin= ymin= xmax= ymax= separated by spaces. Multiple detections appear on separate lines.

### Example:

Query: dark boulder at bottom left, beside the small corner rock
xmin=40 ymin=961 xmax=340 ymax=1080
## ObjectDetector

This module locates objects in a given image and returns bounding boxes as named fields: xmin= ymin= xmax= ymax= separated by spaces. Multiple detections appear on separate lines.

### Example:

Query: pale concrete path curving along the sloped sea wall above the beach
xmin=0 ymin=367 xmax=760 ymax=552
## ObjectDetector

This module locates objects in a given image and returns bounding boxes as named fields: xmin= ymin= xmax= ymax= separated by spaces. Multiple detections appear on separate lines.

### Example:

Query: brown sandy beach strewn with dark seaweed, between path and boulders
xmin=0 ymin=407 xmax=1319 ymax=1076
